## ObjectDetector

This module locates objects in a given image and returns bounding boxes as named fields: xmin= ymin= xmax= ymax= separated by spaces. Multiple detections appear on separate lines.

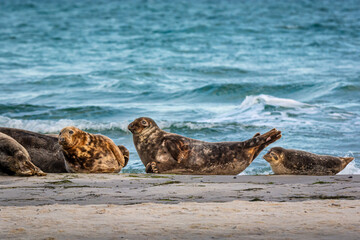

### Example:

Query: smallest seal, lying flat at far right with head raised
xmin=263 ymin=147 xmax=354 ymax=175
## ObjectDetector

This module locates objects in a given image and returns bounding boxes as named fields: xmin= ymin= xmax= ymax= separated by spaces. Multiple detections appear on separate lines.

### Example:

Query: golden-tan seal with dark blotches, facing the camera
xmin=59 ymin=127 xmax=129 ymax=173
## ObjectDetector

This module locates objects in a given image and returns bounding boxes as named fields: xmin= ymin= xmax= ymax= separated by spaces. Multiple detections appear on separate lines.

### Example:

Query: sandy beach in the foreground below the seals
xmin=0 ymin=174 xmax=360 ymax=239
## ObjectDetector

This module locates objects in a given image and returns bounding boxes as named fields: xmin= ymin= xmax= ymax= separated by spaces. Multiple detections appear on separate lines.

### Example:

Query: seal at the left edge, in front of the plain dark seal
xmin=0 ymin=133 xmax=46 ymax=176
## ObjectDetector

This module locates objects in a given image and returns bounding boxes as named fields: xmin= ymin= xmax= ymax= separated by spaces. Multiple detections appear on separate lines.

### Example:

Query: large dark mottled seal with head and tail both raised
xmin=128 ymin=117 xmax=281 ymax=175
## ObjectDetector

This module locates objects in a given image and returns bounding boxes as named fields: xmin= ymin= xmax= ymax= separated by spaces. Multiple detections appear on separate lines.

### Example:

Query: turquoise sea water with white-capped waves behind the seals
xmin=0 ymin=0 xmax=360 ymax=174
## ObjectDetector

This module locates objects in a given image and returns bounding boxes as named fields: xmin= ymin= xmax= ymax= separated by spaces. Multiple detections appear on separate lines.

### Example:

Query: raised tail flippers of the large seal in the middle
xmin=244 ymin=128 xmax=281 ymax=159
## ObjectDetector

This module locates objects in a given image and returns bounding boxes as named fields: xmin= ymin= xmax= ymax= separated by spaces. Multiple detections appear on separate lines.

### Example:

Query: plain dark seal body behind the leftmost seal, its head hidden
xmin=0 ymin=127 xmax=66 ymax=173
